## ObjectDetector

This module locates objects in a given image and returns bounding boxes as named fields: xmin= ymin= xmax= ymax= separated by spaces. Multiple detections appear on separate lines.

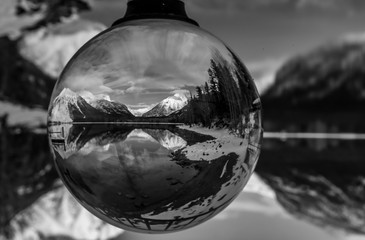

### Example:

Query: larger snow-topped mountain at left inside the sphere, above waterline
xmin=49 ymin=88 xmax=134 ymax=122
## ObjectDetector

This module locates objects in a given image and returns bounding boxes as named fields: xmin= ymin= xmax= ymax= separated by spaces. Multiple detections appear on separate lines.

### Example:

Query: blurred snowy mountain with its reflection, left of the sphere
xmin=0 ymin=0 xmax=122 ymax=239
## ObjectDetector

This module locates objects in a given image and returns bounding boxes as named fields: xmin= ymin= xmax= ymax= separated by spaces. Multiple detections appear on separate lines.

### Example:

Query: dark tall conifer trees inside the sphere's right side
xmin=176 ymin=51 xmax=258 ymax=127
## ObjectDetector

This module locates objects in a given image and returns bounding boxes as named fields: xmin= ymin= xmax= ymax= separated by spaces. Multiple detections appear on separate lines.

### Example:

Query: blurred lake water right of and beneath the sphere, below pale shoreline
xmin=120 ymin=134 xmax=365 ymax=240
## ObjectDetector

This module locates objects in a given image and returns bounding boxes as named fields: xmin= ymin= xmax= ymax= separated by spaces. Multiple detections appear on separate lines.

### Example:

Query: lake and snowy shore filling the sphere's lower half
xmin=50 ymin=124 xmax=253 ymax=231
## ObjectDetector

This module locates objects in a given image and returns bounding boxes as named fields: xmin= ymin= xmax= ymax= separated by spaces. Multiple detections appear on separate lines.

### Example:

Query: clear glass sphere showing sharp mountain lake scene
xmin=48 ymin=19 xmax=262 ymax=233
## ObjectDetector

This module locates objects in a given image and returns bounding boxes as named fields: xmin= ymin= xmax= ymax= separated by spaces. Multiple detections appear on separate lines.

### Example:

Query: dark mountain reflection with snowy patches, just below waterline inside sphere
xmin=49 ymin=123 xmax=218 ymax=152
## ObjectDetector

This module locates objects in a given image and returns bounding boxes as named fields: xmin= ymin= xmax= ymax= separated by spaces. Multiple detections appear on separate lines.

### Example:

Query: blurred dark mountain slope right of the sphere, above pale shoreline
xmin=262 ymin=40 xmax=365 ymax=111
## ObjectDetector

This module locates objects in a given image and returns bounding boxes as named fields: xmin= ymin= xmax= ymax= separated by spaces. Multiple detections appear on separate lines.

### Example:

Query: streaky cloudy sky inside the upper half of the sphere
xmin=59 ymin=21 xmax=232 ymax=109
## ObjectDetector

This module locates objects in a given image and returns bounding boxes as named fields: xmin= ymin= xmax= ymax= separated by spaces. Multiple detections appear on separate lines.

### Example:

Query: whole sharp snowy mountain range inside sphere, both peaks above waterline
xmin=49 ymin=88 xmax=188 ymax=123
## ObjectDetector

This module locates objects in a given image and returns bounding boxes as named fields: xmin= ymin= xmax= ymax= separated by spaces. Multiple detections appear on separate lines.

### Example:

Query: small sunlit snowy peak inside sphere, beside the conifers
xmin=142 ymin=93 xmax=188 ymax=117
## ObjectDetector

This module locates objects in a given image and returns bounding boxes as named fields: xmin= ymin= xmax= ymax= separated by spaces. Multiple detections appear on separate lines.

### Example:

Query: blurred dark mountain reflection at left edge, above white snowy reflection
xmin=0 ymin=126 xmax=58 ymax=235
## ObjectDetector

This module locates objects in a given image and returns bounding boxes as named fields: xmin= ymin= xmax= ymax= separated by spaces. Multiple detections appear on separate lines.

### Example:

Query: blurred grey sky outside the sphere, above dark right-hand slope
xmin=84 ymin=0 xmax=365 ymax=93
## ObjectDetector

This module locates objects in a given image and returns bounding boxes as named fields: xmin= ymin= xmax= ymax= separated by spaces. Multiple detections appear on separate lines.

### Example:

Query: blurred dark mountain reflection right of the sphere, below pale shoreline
xmin=256 ymin=139 xmax=365 ymax=234
